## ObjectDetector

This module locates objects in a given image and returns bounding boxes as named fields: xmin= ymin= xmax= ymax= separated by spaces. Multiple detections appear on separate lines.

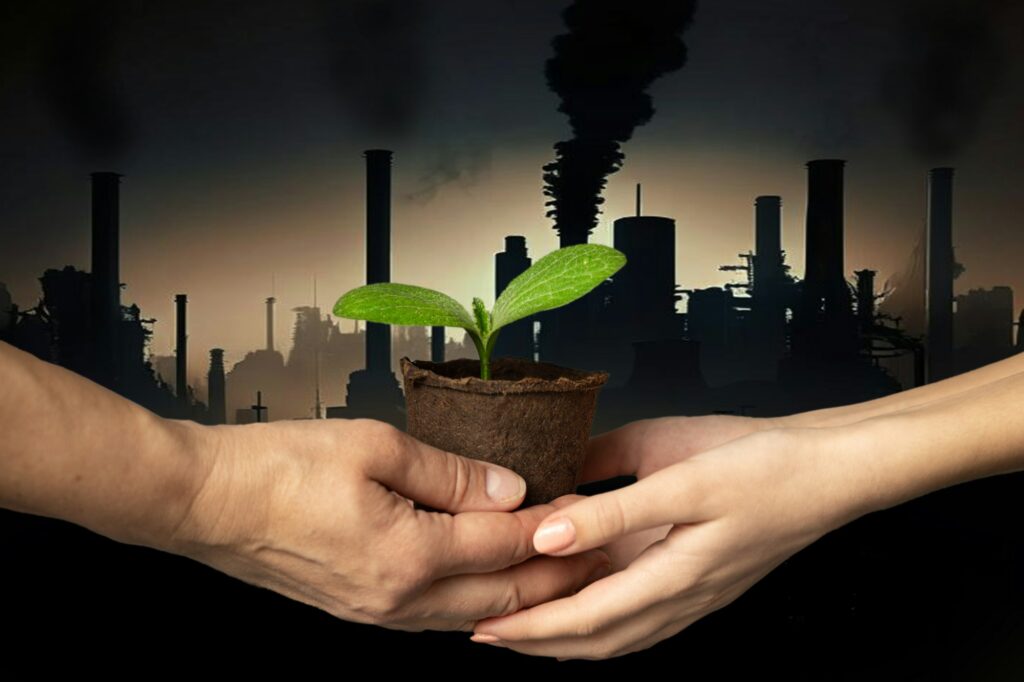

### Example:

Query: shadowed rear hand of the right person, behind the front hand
xmin=582 ymin=415 xmax=775 ymax=570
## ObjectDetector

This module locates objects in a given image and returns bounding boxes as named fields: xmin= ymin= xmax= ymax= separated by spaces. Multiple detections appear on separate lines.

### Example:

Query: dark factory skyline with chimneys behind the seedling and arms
xmin=0 ymin=150 xmax=1024 ymax=429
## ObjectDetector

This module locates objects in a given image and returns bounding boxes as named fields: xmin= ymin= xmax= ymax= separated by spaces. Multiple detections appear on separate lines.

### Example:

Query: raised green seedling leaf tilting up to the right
xmin=490 ymin=244 xmax=626 ymax=332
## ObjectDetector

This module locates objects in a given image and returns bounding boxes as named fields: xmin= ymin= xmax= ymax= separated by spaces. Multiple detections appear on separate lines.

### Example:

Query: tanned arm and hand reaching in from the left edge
xmin=0 ymin=342 xmax=608 ymax=630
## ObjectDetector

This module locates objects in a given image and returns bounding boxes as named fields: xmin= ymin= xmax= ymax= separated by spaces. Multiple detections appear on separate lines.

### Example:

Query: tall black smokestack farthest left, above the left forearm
xmin=91 ymin=172 xmax=122 ymax=387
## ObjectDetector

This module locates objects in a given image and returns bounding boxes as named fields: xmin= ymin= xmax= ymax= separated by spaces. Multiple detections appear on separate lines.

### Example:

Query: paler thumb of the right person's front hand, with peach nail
xmin=534 ymin=462 xmax=706 ymax=556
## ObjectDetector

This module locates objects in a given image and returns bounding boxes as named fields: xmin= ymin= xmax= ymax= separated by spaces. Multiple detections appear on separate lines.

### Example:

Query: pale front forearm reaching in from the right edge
xmin=822 ymin=366 xmax=1024 ymax=516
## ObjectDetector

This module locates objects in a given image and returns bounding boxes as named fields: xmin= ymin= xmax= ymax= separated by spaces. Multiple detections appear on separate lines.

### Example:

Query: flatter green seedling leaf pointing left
xmin=334 ymin=282 xmax=477 ymax=333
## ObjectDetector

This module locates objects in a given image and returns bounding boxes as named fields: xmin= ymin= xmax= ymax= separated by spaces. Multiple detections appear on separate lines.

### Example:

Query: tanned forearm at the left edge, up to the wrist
xmin=0 ymin=342 xmax=203 ymax=546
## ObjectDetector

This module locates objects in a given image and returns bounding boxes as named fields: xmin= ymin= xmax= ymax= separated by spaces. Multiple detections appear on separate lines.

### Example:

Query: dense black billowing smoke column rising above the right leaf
xmin=544 ymin=0 xmax=696 ymax=246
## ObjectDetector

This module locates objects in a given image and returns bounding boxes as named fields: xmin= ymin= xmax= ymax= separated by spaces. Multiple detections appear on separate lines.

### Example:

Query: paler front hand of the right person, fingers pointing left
xmin=473 ymin=421 xmax=863 ymax=658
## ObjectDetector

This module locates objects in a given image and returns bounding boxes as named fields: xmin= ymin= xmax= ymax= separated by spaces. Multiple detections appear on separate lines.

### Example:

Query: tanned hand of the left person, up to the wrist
xmin=162 ymin=419 xmax=607 ymax=631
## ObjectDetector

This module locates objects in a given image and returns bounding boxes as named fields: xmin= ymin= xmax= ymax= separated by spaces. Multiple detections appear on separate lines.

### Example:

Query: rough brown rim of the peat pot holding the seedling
xmin=399 ymin=356 xmax=610 ymax=394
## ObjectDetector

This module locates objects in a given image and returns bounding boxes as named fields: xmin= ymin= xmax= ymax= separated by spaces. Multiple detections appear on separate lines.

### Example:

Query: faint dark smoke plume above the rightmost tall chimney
xmin=882 ymin=0 xmax=1007 ymax=158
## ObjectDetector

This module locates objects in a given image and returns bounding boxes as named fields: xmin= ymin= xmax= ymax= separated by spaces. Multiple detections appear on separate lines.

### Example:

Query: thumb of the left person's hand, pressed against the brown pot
xmin=368 ymin=421 xmax=526 ymax=513
